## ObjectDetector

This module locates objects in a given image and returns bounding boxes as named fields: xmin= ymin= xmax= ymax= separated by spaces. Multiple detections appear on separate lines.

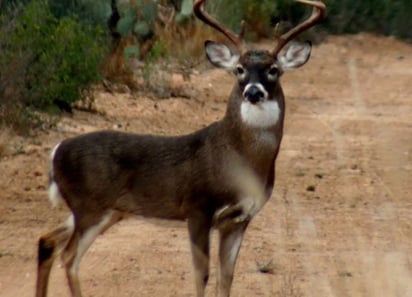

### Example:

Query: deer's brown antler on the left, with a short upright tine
xmin=194 ymin=0 xmax=246 ymax=52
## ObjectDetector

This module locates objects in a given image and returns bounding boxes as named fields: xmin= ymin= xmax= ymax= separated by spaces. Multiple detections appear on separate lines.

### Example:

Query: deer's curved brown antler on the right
xmin=272 ymin=0 xmax=326 ymax=56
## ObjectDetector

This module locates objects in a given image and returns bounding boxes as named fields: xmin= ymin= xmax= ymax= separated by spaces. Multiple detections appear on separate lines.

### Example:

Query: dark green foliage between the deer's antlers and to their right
xmin=209 ymin=0 xmax=412 ymax=41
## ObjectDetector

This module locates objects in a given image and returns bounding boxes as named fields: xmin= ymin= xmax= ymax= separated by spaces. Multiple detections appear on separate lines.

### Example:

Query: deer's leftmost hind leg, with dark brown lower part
xmin=36 ymin=215 xmax=74 ymax=297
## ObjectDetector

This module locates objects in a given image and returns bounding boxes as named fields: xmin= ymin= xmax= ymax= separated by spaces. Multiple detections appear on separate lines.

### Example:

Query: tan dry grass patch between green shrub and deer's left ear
xmin=101 ymin=21 xmax=226 ymax=98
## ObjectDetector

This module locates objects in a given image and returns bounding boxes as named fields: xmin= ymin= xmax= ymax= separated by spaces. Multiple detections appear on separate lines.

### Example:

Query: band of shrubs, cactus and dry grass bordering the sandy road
xmin=0 ymin=0 xmax=412 ymax=134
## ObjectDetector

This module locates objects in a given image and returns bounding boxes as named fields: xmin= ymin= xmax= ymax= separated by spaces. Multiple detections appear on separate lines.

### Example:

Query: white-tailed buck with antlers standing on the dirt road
xmin=36 ymin=0 xmax=326 ymax=297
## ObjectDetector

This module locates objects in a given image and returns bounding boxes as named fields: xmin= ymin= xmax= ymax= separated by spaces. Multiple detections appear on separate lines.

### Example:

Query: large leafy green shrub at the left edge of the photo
xmin=0 ymin=0 xmax=107 ymax=132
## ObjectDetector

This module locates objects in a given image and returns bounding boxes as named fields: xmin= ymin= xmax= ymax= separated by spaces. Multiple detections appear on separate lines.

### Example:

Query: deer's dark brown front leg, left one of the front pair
xmin=188 ymin=211 xmax=212 ymax=297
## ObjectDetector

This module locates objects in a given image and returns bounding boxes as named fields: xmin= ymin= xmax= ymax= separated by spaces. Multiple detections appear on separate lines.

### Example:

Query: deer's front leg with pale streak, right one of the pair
xmin=218 ymin=220 xmax=249 ymax=297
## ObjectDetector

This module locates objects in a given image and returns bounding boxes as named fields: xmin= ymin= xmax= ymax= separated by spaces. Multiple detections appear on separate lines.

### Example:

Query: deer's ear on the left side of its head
xmin=205 ymin=40 xmax=239 ymax=70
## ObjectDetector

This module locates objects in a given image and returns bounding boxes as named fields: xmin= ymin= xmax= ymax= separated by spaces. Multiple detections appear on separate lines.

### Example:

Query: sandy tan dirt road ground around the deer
xmin=0 ymin=34 xmax=412 ymax=297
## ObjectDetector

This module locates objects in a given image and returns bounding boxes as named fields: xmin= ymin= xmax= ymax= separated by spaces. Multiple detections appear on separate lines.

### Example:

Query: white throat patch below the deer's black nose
xmin=240 ymin=100 xmax=280 ymax=128
